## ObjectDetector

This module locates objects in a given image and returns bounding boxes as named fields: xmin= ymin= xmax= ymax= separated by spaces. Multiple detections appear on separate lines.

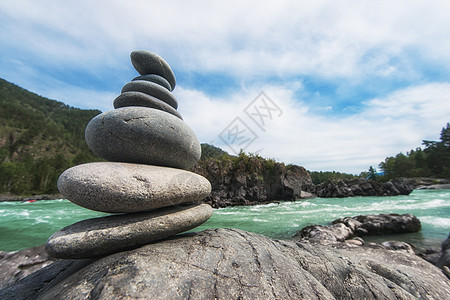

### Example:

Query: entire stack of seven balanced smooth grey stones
xmin=46 ymin=50 xmax=212 ymax=258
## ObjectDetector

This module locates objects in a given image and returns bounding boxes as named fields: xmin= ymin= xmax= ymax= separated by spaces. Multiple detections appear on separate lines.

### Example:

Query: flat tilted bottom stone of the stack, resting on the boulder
xmin=46 ymin=204 xmax=213 ymax=258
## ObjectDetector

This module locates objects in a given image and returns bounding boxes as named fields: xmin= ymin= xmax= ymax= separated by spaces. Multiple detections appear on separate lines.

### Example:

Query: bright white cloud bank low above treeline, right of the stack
xmin=177 ymin=83 xmax=450 ymax=173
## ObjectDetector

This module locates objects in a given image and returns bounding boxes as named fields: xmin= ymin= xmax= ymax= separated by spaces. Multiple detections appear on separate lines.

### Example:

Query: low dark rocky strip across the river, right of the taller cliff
xmin=314 ymin=178 xmax=415 ymax=198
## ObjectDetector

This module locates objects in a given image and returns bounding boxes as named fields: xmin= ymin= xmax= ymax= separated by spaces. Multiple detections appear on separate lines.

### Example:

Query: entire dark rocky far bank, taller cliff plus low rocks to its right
xmin=192 ymin=157 xmax=417 ymax=208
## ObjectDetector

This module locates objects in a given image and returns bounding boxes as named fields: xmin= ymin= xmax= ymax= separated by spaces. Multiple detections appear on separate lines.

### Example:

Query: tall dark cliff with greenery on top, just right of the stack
xmin=192 ymin=157 xmax=314 ymax=208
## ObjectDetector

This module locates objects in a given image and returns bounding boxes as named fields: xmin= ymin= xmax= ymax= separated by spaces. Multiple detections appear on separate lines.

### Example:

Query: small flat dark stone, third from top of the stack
xmin=122 ymin=80 xmax=178 ymax=109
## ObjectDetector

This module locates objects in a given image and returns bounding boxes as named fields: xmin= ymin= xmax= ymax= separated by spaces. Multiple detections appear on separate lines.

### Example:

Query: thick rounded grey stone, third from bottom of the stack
xmin=85 ymin=106 xmax=201 ymax=169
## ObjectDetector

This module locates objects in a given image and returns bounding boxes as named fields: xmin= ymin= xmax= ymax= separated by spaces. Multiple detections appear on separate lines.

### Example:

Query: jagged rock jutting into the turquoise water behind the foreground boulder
xmin=294 ymin=214 xmax=421 ymax=241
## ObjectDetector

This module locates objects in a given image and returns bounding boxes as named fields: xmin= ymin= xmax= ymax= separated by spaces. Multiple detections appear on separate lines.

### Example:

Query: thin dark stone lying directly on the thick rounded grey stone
xmin=113 ymin=92 xmax=183 ymax=120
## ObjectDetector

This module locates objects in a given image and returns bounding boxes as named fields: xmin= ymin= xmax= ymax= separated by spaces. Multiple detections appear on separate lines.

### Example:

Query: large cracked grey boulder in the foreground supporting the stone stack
xmin=0 ymin=229 xmax=450 ymax=299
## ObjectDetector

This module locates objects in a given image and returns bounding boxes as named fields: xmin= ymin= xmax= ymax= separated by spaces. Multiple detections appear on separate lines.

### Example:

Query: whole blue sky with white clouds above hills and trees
xmin=0 ymin=0 xmax=450 ymax=174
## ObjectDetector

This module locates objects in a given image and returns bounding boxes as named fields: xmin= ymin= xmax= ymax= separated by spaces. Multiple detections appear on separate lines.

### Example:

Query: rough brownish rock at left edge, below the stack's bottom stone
xmin=0 ymin=245 xmax=55 ymax=289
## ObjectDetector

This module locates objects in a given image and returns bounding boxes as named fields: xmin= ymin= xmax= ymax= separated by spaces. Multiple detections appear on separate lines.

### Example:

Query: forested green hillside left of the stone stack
xmin=0 ymin=79 xmax=101 ymax=195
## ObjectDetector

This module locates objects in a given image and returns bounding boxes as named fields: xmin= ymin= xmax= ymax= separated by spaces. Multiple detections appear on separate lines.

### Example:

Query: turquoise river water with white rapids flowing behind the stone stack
xmin=0 ymin=190 xmax=450 ymax=251
